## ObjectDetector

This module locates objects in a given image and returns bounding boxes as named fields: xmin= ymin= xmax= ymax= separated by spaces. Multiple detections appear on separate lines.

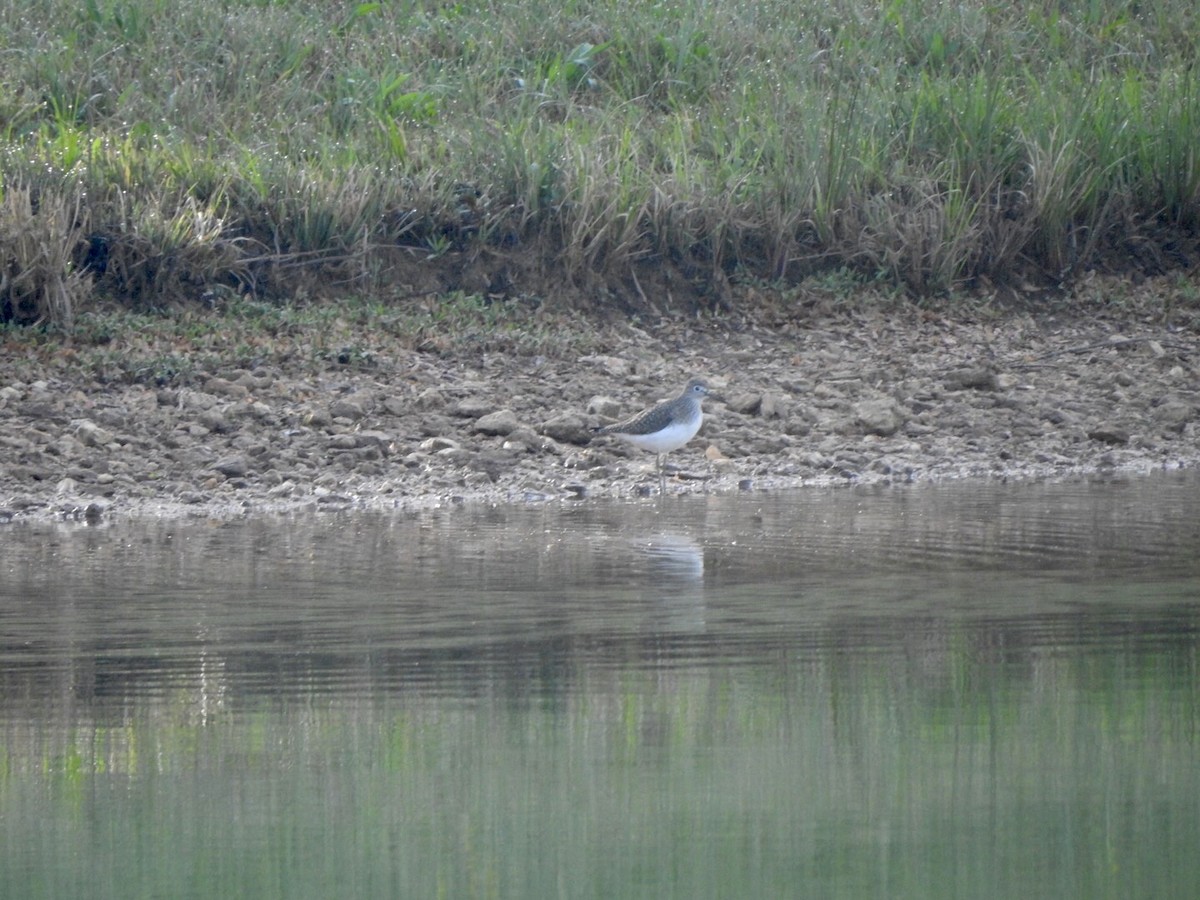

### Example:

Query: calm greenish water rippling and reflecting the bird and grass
xmin=0 ymin=475 xmax=1200 ymax=900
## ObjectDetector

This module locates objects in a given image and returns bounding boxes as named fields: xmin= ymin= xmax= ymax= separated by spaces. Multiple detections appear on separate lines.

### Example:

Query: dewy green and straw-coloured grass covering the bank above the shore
xmin=0 ymin=0 xmax=1200 ymax=326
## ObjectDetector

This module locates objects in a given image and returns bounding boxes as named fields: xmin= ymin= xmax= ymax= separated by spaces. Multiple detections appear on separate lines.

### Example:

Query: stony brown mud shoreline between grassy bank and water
xmin=0 ymin=300 xmax=1200 ymax=522
